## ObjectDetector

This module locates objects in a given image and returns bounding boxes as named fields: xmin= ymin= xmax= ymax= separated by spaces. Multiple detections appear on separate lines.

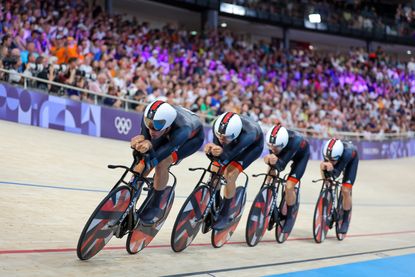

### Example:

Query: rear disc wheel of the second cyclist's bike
xmin=211 ymin=187 xmax=246 ymax=248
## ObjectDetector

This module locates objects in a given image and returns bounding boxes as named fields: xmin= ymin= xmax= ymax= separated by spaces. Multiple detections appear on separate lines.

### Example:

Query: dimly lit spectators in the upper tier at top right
xmin=223 ymin=0 xmax=415 ymax=36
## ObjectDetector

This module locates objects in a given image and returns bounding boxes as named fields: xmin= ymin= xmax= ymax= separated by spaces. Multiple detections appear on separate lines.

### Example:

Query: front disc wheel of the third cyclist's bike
xmin=245 ymin=187 xmax=273 ymax=246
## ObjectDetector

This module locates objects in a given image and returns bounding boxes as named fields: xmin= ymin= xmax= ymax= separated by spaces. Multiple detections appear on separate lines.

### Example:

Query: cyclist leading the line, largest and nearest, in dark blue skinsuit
xmin=131 ymin=100 xmax=204 ymax=224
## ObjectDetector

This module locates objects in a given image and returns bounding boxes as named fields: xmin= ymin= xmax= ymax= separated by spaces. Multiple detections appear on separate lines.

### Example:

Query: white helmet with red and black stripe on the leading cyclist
xmin=144 ymin=100 xmax=177 ymax=131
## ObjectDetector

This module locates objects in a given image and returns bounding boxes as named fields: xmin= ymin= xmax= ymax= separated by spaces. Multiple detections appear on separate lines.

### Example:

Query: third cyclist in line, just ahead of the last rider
xmin=264 ymin=124 xmax=310 ymax=233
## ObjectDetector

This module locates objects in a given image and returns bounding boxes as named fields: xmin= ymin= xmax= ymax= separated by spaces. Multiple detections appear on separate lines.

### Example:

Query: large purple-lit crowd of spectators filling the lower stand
xmin=0 ymin=0 xmax=415 ymax=138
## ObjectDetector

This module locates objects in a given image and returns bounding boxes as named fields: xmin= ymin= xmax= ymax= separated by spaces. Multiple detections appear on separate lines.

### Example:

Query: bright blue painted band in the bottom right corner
xmin=267 ymin=254 xmax=415 ymax=277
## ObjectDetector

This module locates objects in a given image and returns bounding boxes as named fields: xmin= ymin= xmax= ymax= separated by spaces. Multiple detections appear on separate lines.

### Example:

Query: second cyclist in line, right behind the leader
xmin=205 ymin=112 xmax=264 ymax=230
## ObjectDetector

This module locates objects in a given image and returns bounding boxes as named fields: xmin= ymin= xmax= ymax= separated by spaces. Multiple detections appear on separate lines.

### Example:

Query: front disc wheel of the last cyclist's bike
xmin=313 ymin=189 xmax=333 ymax=243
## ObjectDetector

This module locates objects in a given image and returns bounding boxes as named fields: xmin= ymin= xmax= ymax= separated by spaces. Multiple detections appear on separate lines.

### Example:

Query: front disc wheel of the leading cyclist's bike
xmin=76 ymin=186 xmax=131 ymax=260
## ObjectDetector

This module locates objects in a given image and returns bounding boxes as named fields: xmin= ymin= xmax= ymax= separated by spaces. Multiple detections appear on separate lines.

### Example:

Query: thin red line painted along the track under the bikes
xmin=0 ymin=230 xmax=415 ymax=255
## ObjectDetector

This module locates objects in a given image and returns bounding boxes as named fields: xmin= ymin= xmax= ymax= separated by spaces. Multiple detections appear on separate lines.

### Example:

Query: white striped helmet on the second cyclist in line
xmin=213 ymin=112 xmax=242 ymax=143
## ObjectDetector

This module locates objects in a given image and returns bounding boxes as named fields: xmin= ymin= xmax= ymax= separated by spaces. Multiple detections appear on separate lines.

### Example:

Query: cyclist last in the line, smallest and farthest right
xmin=320 ymin=138 xmax=359 ymax=234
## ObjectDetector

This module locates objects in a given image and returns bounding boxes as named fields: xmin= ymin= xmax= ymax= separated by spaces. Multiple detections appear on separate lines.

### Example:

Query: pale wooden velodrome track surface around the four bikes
xmin=0 ymin=121 xmax=415 ymax=277
